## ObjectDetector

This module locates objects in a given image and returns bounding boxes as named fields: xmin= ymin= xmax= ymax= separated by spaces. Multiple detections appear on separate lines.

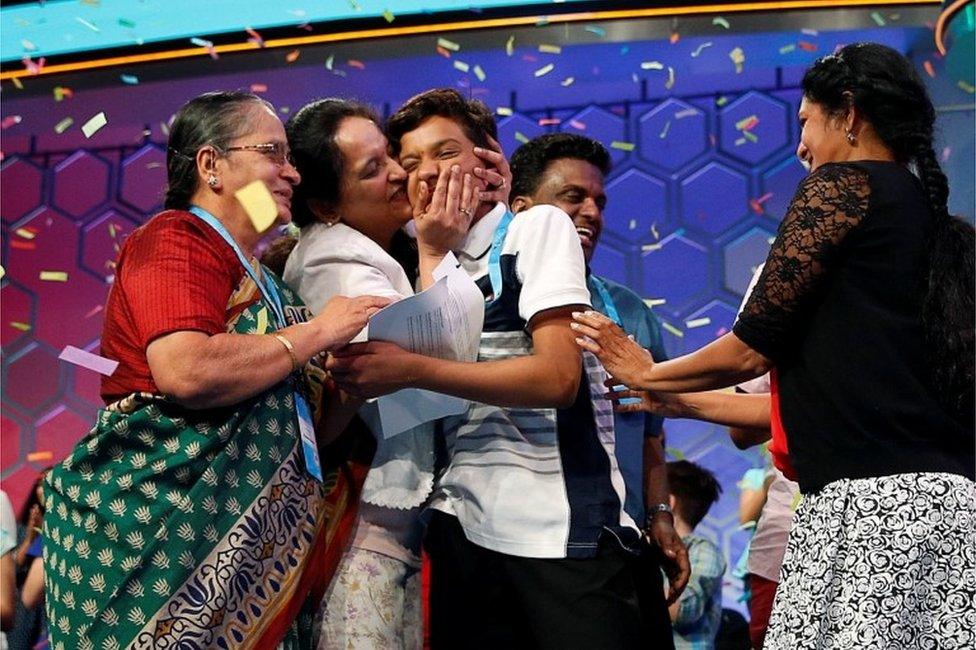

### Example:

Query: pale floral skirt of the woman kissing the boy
xmin=318 ymin=548 xmax=424 ymax=650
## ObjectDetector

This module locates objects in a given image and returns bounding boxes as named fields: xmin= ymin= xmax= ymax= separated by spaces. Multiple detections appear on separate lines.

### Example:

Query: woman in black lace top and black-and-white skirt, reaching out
xmin=574 ymin=44 xmax=976 ymax=650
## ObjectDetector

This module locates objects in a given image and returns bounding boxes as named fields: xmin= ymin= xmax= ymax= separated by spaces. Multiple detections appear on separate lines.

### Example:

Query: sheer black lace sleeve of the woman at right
xmin=733 ymin=165 xmax=870 ymax=362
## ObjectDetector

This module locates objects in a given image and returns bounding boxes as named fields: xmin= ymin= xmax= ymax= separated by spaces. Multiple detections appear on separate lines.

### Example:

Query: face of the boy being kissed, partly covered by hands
xmin=399 ymin=115 xmax=485 ymax=210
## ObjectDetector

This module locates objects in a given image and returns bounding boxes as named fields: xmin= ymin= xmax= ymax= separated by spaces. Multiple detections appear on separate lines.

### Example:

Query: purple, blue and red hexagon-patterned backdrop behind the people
xmin=0 ymin=17 xmax=971 ymax=606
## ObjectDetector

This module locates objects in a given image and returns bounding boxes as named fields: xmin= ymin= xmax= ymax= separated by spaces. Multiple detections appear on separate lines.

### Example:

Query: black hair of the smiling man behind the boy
xmin=509 ymin=133 xmax=612 ymax=197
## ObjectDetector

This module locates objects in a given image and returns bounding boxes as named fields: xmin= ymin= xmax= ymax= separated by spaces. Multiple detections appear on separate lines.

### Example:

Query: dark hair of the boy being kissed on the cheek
xmin=386 ymin=88 xmax=498 ymax=157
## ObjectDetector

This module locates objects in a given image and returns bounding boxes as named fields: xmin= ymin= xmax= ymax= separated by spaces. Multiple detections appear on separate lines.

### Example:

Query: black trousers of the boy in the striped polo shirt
xmin=424 ymin=512 xmax=645 ymax=650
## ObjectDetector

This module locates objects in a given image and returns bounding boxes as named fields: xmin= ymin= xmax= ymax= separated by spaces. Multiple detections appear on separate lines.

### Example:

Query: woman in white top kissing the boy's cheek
xmin=284 ymin=98 xmax=508 ymax=648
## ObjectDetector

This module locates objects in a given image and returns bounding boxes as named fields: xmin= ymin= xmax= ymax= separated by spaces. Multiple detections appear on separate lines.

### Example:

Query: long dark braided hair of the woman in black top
xmin=803 ymin=43 xmax=976 ymax=418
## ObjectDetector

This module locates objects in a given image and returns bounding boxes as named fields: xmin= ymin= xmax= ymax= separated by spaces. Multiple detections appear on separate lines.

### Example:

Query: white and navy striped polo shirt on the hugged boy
xmin=430 ymin=204 xmax=639 ymax=558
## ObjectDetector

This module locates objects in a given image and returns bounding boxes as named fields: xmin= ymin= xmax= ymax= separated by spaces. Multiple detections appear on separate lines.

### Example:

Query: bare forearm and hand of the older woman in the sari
xmin=146 ymin=296 xmax=389 ymax=409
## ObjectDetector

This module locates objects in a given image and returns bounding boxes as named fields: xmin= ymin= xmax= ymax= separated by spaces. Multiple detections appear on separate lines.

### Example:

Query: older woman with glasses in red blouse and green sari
xmin=44 ymin=92 xmax=386 ymax=649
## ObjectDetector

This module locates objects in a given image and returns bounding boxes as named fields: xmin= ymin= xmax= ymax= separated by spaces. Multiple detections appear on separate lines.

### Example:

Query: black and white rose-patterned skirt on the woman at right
xmin=764 ymin=473 xmax=976 ymax=650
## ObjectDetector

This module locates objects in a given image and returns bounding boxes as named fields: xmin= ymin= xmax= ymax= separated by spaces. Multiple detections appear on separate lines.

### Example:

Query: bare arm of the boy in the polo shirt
xmin=326 ymin=307 xmax=581 ymax=408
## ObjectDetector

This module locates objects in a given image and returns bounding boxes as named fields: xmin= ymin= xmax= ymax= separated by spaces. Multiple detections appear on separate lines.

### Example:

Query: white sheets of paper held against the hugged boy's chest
xmin=369 ymin=253 xmax=485 ymax=438
